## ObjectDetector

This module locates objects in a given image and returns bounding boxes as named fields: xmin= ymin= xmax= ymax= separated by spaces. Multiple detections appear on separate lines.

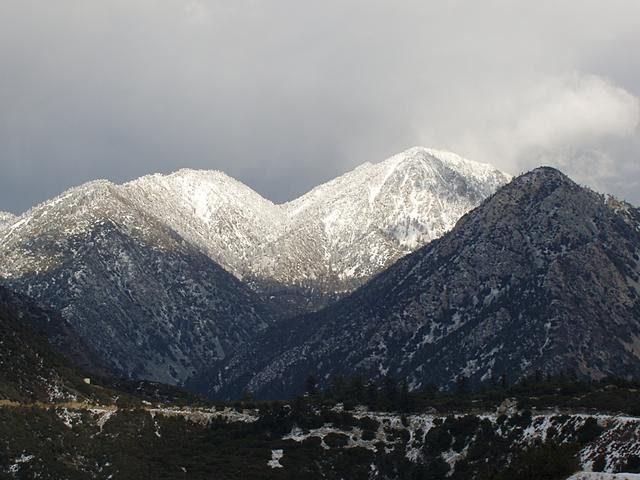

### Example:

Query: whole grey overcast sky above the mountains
xmin=0 ymin=0 xmax=640 ymax=213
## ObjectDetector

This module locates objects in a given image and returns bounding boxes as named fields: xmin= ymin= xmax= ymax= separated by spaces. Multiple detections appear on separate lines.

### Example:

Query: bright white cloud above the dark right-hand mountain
xmin=447 ymin=72 xmax=640 ymax=172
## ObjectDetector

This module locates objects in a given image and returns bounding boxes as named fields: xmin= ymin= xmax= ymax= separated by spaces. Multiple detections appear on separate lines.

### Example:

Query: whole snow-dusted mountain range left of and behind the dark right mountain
xmin=0 ymin=148 xmax=510 ymax=384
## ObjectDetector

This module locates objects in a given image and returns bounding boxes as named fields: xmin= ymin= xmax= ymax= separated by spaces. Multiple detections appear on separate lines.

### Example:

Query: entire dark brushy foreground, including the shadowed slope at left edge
xmin=0 ymin=280 xmax=640 ymax=480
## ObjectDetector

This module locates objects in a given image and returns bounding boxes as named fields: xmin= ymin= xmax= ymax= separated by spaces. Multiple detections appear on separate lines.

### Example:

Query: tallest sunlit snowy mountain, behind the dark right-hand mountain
xmin=272 ymin=147 xmax=510 ymax=291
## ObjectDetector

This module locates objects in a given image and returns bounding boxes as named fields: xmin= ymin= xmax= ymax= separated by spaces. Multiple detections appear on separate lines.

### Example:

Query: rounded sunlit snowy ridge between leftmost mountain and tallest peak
xmin=122 ymin=169 xmax=283 ymax=278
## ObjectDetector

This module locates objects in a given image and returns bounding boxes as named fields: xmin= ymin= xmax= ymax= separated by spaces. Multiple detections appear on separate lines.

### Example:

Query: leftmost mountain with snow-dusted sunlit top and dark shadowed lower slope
xmin=0 ymin=181 xmax=272 ymax=384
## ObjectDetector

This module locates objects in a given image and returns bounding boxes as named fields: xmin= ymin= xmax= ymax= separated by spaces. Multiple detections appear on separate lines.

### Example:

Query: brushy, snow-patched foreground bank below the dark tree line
xmin=0 ymin=405 xmax=640 ymax=480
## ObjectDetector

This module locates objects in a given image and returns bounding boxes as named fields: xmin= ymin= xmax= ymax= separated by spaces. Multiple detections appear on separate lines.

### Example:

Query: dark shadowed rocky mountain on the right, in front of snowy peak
xmin=192 ymin=168 xmax=640 ymax=397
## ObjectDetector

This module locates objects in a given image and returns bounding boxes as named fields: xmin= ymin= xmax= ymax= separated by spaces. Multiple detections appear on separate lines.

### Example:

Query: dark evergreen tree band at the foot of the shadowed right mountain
xmin=296 ymin=373 xmax=640 ymax=416
